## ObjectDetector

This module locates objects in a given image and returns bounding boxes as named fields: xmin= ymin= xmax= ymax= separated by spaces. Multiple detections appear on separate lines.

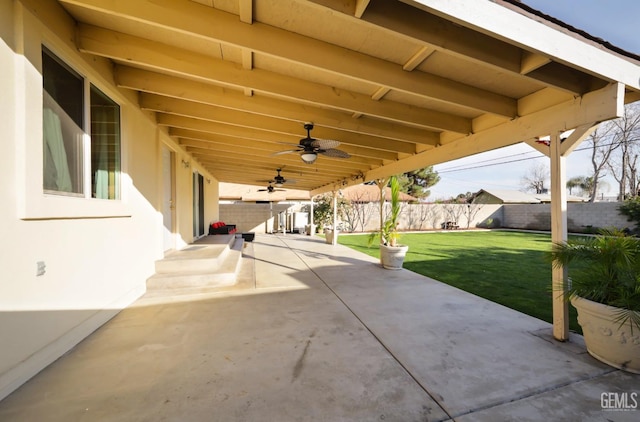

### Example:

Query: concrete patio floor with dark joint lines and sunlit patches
xmin=0 ymin=234 xmax=640 ymax=422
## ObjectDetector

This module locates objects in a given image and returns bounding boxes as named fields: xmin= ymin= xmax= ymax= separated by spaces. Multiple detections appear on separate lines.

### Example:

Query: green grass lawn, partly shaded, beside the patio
xmin=339 ymin=231 xmax=582 ymax=333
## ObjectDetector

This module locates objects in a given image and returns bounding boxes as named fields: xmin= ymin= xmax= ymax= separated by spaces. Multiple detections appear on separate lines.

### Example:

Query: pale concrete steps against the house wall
xmin=147 ymin=235 xmax=244 ymax=291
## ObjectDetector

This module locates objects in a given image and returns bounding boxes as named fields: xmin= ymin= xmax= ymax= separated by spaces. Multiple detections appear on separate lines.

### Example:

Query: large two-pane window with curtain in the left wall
xmin=42 ymin=47 xmax=120 ymax=199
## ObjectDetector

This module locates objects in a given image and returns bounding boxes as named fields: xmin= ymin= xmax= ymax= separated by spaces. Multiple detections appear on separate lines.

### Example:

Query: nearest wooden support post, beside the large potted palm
xmin=549 ymin=133 xmax=569 ymax=341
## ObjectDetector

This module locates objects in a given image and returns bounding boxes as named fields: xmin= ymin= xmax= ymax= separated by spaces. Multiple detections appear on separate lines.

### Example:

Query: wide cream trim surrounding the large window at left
xmin=15 ymin=39 xmax=132 ymax=220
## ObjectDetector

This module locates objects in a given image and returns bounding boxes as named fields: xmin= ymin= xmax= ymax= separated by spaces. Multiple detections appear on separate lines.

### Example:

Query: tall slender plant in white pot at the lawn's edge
xmin=369 ymin=176 xmax=409 ymax=270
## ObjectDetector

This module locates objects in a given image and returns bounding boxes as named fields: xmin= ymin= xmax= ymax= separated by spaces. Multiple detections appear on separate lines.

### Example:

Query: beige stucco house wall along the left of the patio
xmin=0 ymin=0 xmax=218 ymax=399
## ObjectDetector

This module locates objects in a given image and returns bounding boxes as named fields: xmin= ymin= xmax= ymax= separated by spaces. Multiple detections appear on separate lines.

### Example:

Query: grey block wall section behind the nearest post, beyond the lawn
xmin=503 ymin=202 xmax=634 ymax=232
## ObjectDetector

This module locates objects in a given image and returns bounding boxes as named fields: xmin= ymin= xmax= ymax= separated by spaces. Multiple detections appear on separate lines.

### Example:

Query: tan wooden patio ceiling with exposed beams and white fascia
xmin=53 ymin=0 xmax=640 ymax=194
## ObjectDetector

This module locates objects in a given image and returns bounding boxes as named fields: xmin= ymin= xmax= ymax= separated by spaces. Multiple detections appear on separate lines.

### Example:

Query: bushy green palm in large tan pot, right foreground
xmin=551 ymin=230 xmax=640 ymax=373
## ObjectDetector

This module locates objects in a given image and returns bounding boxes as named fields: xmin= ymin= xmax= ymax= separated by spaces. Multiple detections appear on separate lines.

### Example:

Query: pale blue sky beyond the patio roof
xmin=429 ymin=0 xmax=640 ymax=200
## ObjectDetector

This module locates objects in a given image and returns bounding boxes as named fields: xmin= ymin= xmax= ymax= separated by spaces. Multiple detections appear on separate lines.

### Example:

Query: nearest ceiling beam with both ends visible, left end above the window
xmin=77 ymin=24 xmax=471 ymax=134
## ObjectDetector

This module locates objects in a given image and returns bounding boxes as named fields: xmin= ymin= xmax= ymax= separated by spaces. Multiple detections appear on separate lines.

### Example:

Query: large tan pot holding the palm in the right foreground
xmin=571 ymin=297 xmax=640 ymax=374
